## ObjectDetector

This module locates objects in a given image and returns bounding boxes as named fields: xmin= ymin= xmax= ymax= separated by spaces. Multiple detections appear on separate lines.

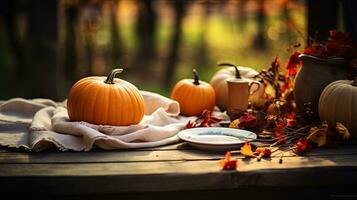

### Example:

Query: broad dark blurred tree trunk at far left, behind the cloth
xmin=26 ymin=0 xmax=59 ymax=100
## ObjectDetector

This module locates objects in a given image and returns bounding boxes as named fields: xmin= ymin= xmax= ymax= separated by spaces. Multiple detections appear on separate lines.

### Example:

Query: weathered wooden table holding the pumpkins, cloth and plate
xmin=0 ymin=143 xmax=357 ymax=199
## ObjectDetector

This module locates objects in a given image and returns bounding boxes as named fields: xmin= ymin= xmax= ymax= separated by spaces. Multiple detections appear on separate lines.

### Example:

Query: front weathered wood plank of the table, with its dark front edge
xmin=0 ymin=155 xmax=357 ymax=194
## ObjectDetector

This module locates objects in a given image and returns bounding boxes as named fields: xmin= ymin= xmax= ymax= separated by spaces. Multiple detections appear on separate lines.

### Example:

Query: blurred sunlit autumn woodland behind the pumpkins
xmin=0 ymin=0 xmax=307 ymax=100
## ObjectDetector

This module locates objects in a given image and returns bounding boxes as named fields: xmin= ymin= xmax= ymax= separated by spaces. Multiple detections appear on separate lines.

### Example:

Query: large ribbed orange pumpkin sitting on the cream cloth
xmin=67 ymin=69 xmax=144 ymax=126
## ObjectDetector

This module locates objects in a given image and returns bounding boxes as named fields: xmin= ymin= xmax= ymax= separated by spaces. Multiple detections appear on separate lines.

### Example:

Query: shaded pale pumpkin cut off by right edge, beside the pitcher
xmin=318 ymin=78 xmax=357 ymax=138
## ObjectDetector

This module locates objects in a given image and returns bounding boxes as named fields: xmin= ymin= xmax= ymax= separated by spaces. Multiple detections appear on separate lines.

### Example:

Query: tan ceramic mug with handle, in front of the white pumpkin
xmin=226 ymin=78 xmax=261 ymax=119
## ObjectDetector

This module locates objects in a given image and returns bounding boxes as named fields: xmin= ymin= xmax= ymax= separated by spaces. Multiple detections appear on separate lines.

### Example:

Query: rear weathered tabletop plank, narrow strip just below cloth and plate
xmin=0 ymin=146 xmax=357 ymax=164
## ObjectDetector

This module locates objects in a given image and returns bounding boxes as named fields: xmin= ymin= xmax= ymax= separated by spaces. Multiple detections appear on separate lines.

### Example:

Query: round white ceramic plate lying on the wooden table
xmin=177 ymin=127 xmax=257 ymax=151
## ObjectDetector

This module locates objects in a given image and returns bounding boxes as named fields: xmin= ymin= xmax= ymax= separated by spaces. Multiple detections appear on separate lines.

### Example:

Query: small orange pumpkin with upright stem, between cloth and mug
xmin=171 ymin=70 xmax=216 ymax=116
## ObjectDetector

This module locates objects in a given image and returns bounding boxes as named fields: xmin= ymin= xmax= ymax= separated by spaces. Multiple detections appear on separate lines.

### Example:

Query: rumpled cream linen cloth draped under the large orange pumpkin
xmin=0 ymin=91 xmax=228 ymax=151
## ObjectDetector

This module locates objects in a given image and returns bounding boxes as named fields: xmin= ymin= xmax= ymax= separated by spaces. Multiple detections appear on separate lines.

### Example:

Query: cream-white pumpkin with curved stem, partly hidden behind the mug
xmin=210 ymin=63 xmax=264 ymax=110
